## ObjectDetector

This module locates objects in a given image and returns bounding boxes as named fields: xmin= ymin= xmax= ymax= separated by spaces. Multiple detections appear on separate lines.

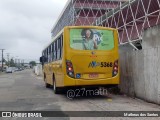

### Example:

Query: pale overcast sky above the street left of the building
xmin=0 ymin=0 xmax=67 ymax=61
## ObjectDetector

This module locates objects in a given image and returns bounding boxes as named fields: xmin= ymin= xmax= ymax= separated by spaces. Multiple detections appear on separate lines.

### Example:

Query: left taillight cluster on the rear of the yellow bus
xmin=66 ymin=60 xmax=74 ymax=78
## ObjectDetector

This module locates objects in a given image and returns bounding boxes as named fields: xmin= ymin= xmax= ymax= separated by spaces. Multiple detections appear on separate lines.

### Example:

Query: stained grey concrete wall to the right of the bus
xmin=120 ymin=26 xmax=160 ymax=104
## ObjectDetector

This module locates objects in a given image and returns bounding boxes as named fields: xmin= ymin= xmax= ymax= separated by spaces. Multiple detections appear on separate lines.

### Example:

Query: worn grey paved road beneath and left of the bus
xmin=0 ymin=70 xmax=160 ymax=120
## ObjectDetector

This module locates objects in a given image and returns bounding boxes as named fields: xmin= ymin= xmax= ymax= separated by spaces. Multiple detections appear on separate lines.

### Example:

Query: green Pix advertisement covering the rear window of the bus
xmin=70 ymin=28 xmax=114 ymax=50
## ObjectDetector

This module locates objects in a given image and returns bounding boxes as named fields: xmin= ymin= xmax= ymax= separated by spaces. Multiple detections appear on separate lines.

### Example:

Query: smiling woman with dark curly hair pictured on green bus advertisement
xmin=81 ymin=29 xmax=98 ymax=50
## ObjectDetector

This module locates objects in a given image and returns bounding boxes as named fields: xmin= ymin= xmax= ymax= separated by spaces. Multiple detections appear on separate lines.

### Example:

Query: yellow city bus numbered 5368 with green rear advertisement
xmin=40 ymin=26 xmax=119 ymax=94
